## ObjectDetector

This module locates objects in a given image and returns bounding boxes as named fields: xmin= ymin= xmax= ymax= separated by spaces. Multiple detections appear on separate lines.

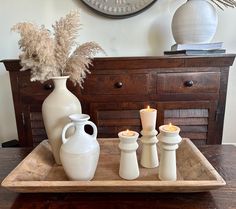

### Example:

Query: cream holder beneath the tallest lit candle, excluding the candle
xmin=140 ymin=130 xmax=159 ymax=168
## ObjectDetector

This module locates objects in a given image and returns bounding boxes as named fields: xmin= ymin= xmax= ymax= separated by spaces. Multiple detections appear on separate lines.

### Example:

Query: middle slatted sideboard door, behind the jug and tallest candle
xmin=90 ymin=102 xmax=155 ymax=138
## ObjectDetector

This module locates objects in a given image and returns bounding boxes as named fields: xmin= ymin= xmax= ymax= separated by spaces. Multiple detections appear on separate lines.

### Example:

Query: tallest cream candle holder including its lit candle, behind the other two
xmin=140 ymin=106 xmax=159 ymax=168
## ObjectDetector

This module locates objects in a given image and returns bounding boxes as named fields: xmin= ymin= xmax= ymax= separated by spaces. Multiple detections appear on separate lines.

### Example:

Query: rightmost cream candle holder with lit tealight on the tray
xmin=157 ymin=124 xmax=182 ymax=181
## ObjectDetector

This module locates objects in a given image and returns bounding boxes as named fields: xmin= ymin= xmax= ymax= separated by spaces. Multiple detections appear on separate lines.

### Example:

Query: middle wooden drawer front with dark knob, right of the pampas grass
xmin=82 ymin=73 xmax=149 ymax=95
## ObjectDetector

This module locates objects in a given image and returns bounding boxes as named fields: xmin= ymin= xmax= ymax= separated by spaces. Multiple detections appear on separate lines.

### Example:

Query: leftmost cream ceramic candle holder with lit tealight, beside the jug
xmin=118 ymin=131 xmax=139 ymax=180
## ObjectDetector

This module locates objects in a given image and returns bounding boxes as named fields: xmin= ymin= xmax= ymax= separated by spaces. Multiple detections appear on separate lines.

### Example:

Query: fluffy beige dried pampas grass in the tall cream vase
xmin=12 ymin=11 xmax=105 ymax=87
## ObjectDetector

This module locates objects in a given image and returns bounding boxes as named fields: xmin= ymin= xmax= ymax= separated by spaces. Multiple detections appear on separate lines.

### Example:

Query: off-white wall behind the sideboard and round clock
xmin=0 ymin=0 xmax=236 ymax=143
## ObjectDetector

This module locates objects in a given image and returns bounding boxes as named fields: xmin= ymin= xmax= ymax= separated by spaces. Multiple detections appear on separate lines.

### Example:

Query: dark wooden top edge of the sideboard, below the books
xmin=0 ymin=54 xmax=236 ymax=71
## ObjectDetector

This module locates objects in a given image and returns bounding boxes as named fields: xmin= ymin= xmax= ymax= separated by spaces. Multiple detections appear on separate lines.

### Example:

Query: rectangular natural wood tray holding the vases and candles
xmin=2 ymin=139 xmax=226 ymax=192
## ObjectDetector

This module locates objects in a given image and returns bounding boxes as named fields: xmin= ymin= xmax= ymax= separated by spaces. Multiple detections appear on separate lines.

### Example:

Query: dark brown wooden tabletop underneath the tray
xmin=0 ymin=145 xmax=236 ymax=209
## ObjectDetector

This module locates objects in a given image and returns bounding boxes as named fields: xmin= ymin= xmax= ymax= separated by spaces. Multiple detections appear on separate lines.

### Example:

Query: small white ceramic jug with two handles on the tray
xmin=60 ymin=114 xmax=100 ymax=181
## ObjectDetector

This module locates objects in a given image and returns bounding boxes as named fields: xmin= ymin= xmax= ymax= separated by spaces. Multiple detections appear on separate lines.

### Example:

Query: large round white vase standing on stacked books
xmin=171 ymin=0 xmax=218 ymax=44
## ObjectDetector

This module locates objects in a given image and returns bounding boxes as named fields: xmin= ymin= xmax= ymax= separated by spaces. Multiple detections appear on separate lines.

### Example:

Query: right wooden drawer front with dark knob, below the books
xmin=157 ymin=72 xmax=220 ymax=94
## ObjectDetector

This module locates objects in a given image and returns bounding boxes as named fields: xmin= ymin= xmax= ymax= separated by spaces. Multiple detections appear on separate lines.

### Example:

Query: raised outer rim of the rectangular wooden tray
xmin=1 ymin=138 xmax=226 ymax=193
